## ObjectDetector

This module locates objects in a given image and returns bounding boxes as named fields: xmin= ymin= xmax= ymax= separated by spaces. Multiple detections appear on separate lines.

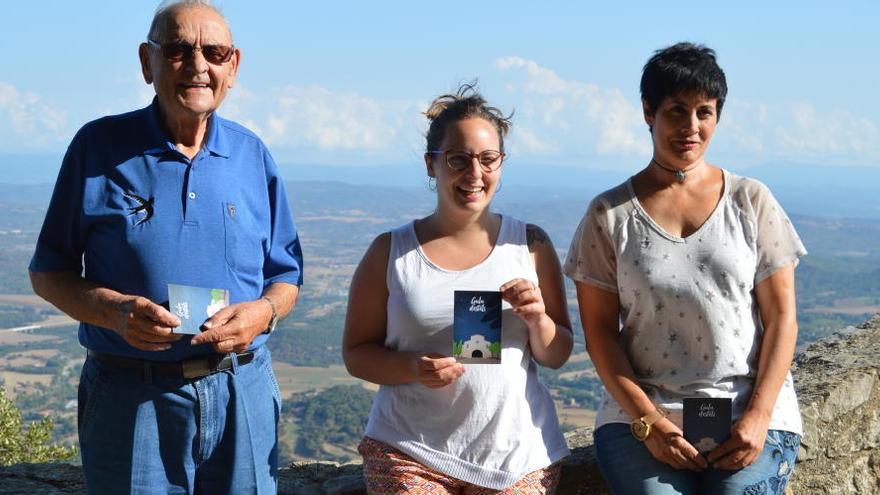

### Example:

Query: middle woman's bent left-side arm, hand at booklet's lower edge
xmin=342 ymin=233 xmax=464 ymax=387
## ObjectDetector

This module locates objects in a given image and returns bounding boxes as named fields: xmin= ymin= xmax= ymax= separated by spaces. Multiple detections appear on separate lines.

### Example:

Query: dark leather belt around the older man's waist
xmin=89 ymin=351 xmax=254 ymax=378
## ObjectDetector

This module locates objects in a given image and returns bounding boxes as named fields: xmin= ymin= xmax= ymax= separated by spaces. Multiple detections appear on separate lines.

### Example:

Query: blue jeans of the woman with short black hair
xmin=593 ymin=423 xmax=800 ymax=495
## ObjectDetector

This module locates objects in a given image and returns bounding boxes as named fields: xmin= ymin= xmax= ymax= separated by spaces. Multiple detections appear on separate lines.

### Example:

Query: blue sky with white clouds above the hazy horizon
xmin=0 ymin=0 xmax=880 ymax=174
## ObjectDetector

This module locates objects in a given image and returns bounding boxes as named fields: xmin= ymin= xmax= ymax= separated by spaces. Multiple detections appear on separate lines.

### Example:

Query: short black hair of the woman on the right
xmin=639 ymin=42 xmax=727 ymax=119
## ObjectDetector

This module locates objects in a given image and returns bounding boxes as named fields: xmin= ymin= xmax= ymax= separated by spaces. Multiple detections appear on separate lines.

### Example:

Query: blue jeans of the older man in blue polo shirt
xmin=78 ymin=346 xmax=281 ymax=495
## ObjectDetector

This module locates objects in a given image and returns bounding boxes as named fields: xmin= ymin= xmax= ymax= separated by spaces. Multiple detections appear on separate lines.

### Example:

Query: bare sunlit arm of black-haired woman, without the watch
xmin=709 ymin=265 xmax=797 ymax=469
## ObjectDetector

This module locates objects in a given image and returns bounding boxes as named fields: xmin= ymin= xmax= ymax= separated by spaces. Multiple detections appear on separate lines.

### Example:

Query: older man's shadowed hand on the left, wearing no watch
xmin=113 ymin=296 xmax=182 ymax=351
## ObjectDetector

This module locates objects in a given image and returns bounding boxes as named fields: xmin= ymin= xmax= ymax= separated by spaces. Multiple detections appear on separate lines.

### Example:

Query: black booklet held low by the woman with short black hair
xmin=683 ymin=397 xmax=732 ymax=454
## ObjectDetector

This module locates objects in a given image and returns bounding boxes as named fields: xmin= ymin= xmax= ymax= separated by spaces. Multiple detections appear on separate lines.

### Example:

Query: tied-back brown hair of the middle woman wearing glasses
xmin=425 ymin=82 xmax=513 ymax=151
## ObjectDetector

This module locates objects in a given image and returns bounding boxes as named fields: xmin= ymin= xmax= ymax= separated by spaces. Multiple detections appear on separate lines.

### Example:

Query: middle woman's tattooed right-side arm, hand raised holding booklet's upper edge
xmin=501 ymin=224 xmax=574 ymax=368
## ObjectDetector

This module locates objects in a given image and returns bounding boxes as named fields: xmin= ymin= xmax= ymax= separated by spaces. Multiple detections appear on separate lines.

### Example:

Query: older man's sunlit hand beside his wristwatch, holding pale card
xmin=190 ymin=299 xmax=272 ymax=354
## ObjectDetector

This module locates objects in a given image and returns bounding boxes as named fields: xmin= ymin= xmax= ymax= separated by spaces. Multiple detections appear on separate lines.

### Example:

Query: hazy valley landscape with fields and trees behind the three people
xmin=0 ymin=181 xmax=880 ymax=459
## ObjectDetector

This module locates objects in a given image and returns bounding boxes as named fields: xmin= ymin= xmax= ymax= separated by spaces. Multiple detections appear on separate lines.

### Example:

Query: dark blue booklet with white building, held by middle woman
xmin=452 ymin=290 xmax=501 ymax=364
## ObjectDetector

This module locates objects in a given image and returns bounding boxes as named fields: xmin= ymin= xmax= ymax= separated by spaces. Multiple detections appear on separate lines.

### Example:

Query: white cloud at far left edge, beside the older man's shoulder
xmin=0 ymin=81 xmax=68 ymax=151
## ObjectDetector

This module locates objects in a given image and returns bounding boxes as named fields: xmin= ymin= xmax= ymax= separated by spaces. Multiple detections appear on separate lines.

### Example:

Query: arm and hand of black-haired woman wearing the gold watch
xmin=576 ymin=282 xmax=706 ymax=471
